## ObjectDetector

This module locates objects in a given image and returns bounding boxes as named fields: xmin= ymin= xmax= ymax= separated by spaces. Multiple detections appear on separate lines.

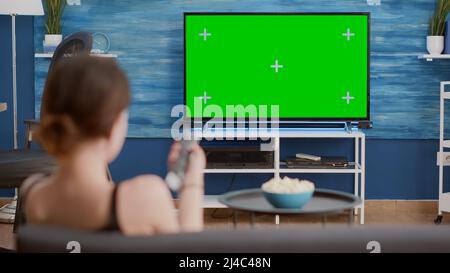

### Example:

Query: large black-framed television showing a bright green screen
xmin=184 ymin=12 xmax=370 ymax=122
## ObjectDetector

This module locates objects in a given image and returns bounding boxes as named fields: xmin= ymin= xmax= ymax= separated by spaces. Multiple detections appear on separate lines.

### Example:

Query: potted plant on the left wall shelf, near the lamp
xmin=44 ymin=0 xmax=66 ymax=52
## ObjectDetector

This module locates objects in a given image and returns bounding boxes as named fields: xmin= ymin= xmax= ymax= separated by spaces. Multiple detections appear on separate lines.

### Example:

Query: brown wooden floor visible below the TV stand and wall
xmin=0 ymin=200 xmax=450 ymax=249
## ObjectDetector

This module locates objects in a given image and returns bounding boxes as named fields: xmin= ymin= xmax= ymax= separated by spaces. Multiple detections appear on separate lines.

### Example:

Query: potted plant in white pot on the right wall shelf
xmin=427 ymin=0 xmax=450 ymax=55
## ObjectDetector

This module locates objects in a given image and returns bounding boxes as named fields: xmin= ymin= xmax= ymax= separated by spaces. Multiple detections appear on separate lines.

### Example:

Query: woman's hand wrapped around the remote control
xmin=168 ymin=142 xmax=206 ymax=186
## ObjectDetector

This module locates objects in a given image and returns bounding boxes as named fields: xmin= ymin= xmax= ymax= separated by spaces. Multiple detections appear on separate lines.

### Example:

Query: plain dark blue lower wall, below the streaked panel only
xmin=111 ymin=139 xmax=438 ymax=199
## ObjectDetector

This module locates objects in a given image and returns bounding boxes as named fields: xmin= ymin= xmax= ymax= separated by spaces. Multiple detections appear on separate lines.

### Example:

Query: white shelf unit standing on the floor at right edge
xmin=435 ymin=81 xmax=450 ymax=221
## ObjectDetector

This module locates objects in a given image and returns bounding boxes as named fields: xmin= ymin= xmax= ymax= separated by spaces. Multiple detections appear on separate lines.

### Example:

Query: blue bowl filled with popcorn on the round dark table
xmin=261 ymin=176 xmax=314 ymax=209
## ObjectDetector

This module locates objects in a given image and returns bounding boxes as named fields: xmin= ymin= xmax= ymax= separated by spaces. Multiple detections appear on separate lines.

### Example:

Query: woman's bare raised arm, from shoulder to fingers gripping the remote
xmin=117 ymin=143 xmax=206 ymax=235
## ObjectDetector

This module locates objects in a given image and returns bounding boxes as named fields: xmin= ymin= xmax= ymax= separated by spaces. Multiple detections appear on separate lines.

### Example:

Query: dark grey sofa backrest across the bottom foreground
xmin=17 ymin=225 xmax=450 ymax=253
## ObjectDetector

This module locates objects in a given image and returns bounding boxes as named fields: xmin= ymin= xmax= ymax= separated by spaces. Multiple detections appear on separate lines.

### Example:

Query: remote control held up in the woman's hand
xmin=165 ymin=140 xmax=197 ymax=191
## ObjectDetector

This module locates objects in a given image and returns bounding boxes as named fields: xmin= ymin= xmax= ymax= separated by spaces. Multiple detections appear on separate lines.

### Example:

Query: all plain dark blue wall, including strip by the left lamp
xmin=0 ymin=6 xmax=446 ymax=199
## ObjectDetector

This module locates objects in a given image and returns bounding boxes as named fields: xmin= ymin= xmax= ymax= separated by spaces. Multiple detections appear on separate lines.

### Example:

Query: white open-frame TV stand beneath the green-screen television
xmin=193 ymin=129 xmax=366 ymax=224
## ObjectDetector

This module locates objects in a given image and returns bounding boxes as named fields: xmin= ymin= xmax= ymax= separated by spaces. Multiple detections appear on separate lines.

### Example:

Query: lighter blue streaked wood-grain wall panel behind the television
xmin=35 ymin=0 xmax=450 ymax=139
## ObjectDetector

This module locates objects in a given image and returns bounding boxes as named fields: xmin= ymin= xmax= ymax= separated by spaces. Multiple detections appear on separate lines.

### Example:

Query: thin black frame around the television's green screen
xmin=183 ymin=12 xmax=370 ymax=123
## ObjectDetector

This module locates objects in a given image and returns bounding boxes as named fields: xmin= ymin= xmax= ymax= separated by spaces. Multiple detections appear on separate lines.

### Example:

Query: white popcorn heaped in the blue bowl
xmin=261 ymin=176 xmax=314 ymax=193
